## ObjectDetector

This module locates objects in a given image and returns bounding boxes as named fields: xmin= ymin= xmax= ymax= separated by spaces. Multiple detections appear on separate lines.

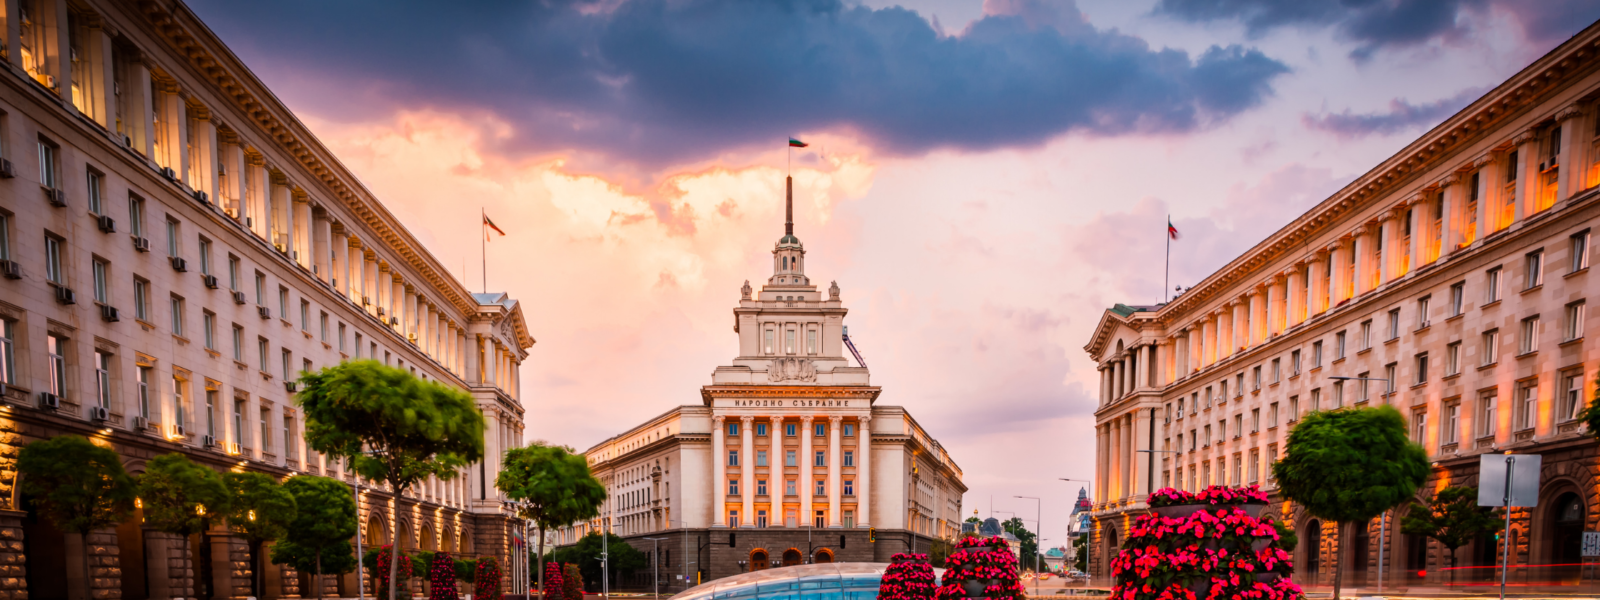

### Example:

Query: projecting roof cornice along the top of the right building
xmin=1158 ymin=24 xmax=1600 ymax=326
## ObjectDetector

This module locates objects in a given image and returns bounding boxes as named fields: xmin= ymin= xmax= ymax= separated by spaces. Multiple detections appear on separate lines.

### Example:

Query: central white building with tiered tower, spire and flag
xmin=557 ymin=178 xmax=966 ymax=590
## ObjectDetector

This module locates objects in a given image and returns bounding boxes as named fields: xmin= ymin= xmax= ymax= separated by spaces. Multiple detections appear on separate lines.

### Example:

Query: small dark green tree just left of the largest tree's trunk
xmin=272 ymin=475 xmax=355 ymax=600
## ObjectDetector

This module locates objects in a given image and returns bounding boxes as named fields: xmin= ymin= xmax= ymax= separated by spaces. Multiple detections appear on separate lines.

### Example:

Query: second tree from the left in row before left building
xmin=139 ymin=453 xmax=232 ymax=595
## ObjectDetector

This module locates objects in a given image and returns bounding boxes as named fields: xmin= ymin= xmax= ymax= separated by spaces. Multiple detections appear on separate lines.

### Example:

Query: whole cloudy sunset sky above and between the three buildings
xmin=190 ymin=0 xmax=1600 ymax=546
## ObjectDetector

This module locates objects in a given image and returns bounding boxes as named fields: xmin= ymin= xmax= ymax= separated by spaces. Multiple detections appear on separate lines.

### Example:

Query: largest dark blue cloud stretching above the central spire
xmin=194 ymin=0 xmax=1288 ymax=166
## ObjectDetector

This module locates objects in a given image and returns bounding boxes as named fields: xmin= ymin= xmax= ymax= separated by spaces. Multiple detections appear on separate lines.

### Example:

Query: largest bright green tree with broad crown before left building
xmin=294 ymin=360 xmax=483 ymax=600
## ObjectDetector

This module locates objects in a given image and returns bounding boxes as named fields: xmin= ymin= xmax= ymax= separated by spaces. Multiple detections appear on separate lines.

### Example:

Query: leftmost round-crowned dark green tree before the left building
xmin=16 ymin=435 xmax=134 ymax=598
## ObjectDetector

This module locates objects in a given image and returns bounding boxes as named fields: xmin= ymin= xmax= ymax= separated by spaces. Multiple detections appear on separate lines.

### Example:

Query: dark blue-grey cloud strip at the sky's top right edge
xmin=1155 ymin=0 xmax=1600 ymax=61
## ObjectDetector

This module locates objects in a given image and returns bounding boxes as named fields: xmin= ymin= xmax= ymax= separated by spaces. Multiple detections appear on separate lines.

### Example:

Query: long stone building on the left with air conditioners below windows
xmin=0 ymin=0 xmax=533 ymax=600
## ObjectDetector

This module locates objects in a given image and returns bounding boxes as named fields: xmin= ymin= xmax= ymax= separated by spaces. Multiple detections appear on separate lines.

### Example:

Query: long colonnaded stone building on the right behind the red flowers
xmin=1086 ymin=26 xmax=1600 ymax=592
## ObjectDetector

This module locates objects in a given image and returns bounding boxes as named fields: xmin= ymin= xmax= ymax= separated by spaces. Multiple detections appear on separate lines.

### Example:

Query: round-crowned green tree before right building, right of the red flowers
xmin=1272 ymin=406 xmax=1429 ymax=600
